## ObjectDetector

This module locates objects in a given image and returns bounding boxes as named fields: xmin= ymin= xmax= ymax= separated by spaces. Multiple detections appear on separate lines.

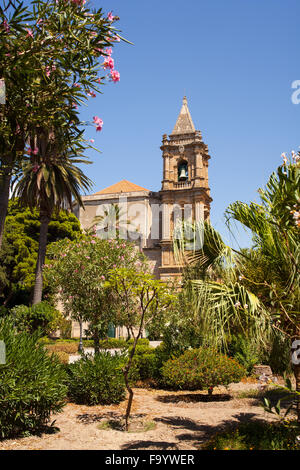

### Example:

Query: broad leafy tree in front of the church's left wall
xmin=45 ymin=236 xmax=146 ymax=354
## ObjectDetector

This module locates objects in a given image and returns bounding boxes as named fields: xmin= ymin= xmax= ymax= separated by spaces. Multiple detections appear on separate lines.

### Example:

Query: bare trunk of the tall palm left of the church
xmin=32 ymin=212 xmax=51 ymax=305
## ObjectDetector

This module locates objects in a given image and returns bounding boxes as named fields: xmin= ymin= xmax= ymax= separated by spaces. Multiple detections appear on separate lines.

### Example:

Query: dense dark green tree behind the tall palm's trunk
xmin=0 ymin=199 xmax=82 ymax=307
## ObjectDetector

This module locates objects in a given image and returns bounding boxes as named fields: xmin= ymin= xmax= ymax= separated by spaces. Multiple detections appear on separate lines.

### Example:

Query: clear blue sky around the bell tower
xmin=24 ymin=0 xmax=300 ymax=246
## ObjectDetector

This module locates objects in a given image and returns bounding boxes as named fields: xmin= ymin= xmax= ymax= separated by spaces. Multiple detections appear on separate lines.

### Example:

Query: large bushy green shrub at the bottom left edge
xmin=0 ymin=318 xmax=67 ymax=438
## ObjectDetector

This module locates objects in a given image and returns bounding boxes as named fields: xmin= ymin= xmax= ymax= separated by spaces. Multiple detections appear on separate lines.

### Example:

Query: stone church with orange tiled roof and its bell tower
xmin=74 ymin=97 xmax=212 ymax=280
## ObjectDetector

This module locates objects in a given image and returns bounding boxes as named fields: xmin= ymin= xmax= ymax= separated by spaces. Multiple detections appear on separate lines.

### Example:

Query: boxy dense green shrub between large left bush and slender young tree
xmin=67 ymin=352 xmax=125 ymax=405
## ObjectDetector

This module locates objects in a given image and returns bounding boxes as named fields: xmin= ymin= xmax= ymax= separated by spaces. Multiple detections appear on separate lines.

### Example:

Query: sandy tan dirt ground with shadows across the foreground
xmin=0 ymin=383 xmax=282 ymax=450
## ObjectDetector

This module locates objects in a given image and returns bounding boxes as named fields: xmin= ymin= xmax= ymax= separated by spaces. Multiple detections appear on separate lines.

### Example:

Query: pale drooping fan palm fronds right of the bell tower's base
xmin=174 ymin=220 xmax=269 ymax=350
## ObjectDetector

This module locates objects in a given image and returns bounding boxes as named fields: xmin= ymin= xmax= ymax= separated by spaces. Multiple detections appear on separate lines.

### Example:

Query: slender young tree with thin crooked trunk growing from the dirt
xmin=107 ymin=267 xmax=175 ymax=431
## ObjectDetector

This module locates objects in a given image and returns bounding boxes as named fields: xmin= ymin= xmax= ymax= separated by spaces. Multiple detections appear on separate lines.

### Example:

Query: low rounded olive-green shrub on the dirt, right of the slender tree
xmin=161 ymin=348 xmax=246 ymax=390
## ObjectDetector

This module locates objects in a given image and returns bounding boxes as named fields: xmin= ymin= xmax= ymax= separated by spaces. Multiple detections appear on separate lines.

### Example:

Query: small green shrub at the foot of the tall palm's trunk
xmin=11 ymin=301 xmax=62 ymax=335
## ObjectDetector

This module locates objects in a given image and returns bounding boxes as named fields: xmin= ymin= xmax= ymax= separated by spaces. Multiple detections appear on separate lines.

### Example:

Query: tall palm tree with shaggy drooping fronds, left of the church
xmin=14 ymin=130 xmax=91 ymax=305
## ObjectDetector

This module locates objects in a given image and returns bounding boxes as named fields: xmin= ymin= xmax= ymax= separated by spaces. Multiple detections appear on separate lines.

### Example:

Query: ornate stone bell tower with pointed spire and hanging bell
xmin=159 ymin=97 xmax=212 ymax=279
